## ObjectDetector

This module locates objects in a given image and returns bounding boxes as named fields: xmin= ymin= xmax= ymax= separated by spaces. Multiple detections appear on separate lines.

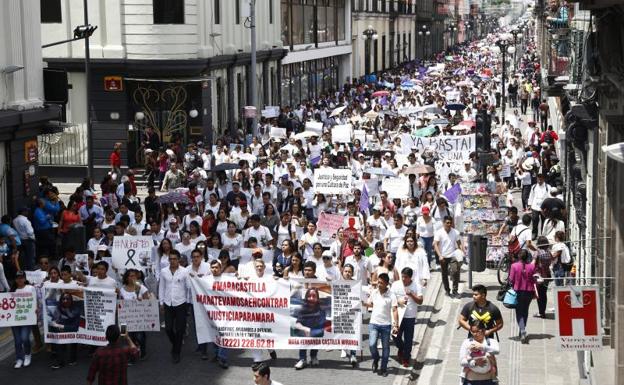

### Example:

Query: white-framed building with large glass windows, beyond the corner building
xmin=280 ymin=0 xmax=352 ymax=107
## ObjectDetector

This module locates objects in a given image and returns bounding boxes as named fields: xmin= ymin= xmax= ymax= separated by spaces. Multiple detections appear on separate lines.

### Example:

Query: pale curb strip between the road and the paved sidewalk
xmin=392 ymin=272 xmax=442 ymax=385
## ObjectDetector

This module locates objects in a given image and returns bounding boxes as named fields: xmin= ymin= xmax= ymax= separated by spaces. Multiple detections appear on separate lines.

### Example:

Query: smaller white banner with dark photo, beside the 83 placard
xmin=43 ymin=283 xmax=117 ymax=346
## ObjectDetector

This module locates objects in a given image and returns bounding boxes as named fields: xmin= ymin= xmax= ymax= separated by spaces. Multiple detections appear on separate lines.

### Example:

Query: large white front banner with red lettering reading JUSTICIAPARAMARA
xmin=191 ymin=276 xmax=362 ymax=350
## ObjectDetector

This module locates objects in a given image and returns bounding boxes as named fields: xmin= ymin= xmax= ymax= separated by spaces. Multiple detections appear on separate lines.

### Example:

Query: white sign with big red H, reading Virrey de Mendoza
xmin=554 ymin=286 xmax=602 ymax=351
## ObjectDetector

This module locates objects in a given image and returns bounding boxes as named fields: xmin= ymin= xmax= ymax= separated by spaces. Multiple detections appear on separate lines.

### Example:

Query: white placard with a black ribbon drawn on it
xmin=112 ymin=235 xmax=154 ymax=270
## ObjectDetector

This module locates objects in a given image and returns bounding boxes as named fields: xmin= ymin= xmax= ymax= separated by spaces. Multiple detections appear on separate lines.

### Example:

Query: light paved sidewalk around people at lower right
xmin=415 ymin=270 xmax=580 ymax=385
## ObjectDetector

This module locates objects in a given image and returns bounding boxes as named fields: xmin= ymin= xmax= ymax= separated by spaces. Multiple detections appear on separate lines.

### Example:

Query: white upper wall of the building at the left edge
xmin=0 ymin=0 xmax=43 ymax=110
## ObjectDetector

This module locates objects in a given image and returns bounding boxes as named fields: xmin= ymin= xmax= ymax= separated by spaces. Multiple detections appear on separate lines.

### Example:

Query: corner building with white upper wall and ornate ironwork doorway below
xmin=40 ymin=0 xmax=286 ymax=179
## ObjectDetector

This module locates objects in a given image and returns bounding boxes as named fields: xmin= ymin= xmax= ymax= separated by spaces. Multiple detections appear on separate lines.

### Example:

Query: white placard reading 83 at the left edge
xmin=0 ymin=290 xmax=37 ymax=328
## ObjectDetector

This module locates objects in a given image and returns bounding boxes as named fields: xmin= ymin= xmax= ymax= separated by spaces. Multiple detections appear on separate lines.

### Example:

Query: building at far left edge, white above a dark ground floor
xmin=0 ymin=0 xmax=60 ymax=215
